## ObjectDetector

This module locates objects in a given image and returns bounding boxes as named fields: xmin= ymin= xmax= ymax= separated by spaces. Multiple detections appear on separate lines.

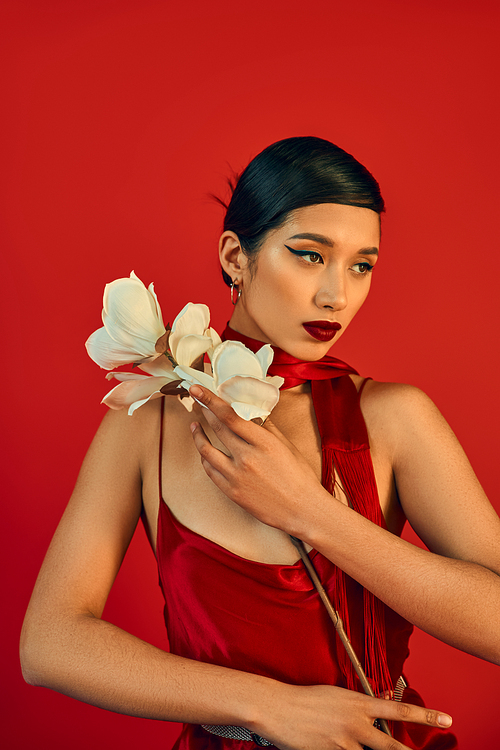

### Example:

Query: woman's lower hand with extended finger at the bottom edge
xmin=252 ymin=684 xmax=451 ymax=750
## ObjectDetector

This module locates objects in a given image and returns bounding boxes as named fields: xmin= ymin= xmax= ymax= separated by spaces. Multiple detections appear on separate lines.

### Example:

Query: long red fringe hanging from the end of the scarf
xmin=322 ymin=446 xmax=394 ymax=695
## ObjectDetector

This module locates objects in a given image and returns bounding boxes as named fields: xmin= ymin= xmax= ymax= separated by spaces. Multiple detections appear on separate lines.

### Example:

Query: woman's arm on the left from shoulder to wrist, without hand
xmin=21 ymin=402 xmax=259 ymax=723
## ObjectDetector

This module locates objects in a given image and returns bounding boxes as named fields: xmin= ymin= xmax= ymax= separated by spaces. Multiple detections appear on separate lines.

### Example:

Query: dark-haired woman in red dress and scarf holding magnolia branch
xmin=22 ymin=138 xmax=500 ymax=750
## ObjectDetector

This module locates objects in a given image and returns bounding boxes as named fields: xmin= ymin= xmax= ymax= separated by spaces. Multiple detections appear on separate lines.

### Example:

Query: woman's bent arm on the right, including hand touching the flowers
xmin=189 ymin=384 xmax=500 ymax=663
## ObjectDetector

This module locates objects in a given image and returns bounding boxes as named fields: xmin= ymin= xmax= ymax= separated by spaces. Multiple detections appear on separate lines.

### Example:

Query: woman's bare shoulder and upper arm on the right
xmin=354 ymin=381 xmax=500 ymax=572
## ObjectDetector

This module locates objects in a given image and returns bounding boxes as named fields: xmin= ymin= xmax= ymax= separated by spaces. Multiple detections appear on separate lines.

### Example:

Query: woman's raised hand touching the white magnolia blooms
xmin=190 ymin=386 xmax=332 ymax=538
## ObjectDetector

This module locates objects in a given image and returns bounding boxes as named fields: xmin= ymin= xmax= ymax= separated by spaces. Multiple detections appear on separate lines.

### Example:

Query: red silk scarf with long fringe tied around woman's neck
xmin=222 ymin=324 xmax=393 ymax=695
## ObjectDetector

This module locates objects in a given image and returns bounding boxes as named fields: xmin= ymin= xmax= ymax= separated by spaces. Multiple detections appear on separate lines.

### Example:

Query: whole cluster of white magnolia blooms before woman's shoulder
xmin=86 ymin=271 xmax=284 ymax=420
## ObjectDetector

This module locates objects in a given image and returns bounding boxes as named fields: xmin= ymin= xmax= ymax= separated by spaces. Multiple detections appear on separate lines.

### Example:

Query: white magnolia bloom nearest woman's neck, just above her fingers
xmin=175 ymin=341 xmax=284 ymax=420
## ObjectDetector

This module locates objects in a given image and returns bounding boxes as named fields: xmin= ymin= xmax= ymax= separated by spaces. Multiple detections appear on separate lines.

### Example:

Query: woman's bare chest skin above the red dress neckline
xmin=143 ymin=391 xmax=398 ymax=564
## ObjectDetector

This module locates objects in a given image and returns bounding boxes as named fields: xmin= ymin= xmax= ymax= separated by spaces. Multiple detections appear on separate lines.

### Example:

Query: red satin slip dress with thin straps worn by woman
xmin=157 ymin=376 xmax=457 ymax=750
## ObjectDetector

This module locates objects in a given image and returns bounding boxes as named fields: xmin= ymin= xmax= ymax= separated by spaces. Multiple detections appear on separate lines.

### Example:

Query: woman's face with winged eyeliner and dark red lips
xmin=226 ymin=203 xmax=380 ymax=360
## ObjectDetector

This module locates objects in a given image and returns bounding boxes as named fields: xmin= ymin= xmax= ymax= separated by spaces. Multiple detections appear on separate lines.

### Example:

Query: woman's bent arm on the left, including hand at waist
xmin=21 ymin=404 xmax=450 ymax=750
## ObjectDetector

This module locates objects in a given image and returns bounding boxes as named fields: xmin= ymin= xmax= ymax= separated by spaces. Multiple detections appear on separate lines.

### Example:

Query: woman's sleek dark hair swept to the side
xmin=218 ymin=136 xmax=385 ymax=286
